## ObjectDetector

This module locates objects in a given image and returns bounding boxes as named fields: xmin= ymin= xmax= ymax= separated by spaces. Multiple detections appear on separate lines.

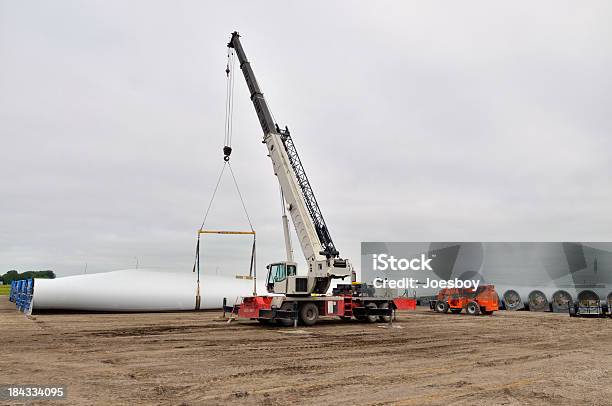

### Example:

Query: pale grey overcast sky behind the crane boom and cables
xmin=0 ymin=0 xmax=612 ymax=275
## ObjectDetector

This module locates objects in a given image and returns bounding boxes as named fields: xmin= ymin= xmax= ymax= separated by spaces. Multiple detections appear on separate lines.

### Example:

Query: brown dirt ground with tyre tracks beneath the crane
xmin=0 ymin=297 xmax=612 ymax=405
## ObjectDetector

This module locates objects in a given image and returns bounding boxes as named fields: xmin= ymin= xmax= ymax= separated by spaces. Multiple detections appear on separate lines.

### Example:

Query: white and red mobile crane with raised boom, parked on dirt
xmin=227 ymin=32 xmax=394 ymax=325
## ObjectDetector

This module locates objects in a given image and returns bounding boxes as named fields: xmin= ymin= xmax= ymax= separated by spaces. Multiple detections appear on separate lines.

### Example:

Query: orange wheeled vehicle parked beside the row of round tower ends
xmin=429 ymin=285 xmax=499 ymax=316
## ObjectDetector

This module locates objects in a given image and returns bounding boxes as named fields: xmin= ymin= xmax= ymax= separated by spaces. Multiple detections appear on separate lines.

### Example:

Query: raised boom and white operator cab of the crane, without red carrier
xmin=227 ymin=32 xmax=352 ymax=295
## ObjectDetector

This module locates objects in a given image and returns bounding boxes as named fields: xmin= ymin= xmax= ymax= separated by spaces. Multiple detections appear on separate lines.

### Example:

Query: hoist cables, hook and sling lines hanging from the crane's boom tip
xmin=192 ymin=48 xmax=256 ymax=302
